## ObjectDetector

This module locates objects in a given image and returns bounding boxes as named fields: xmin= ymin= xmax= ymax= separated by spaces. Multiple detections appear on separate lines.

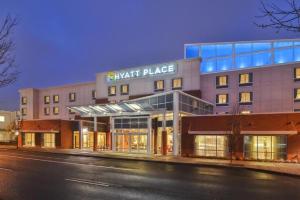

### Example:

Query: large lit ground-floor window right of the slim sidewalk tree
xmin=244 ymin=136 xmax=287 ymax=160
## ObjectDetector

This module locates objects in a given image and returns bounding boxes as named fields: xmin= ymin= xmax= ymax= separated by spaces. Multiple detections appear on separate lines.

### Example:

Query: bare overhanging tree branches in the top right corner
xmin=255 ymin=0 xmax=300 ymax=32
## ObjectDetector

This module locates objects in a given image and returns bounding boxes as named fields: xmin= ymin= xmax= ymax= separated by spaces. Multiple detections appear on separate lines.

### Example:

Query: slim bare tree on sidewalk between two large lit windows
xmin=228 ymin=102 xmax=241 ymax=162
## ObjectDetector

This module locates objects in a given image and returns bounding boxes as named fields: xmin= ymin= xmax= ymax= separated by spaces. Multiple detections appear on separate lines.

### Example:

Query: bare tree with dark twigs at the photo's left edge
xmin=0 ymin=15 xmax=19 ymax=87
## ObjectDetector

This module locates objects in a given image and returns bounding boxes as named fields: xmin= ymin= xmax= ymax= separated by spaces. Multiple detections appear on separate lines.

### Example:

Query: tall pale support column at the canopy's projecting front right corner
xmin=173 ymin=91 xmax=179 ymax=156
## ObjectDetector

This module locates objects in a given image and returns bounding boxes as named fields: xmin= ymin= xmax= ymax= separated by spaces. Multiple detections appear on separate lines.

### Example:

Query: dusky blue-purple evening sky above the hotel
xmin=0 ymin=0 xmax=299 ymax=110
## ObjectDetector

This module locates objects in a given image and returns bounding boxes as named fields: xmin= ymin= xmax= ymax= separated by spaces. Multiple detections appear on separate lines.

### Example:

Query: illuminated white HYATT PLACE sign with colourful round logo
xmin=106 ymin=63 xmax=177 ymax=82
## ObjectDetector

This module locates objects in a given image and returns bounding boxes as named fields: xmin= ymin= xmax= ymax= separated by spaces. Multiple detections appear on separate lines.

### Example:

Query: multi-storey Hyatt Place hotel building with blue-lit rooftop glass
xmin=18 ymin=40 xmax=300 ymax=160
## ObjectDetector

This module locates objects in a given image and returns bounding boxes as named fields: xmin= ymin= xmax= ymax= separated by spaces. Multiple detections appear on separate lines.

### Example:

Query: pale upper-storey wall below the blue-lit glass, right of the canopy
xmin=200 ymin=64 xmax=300 ymax=113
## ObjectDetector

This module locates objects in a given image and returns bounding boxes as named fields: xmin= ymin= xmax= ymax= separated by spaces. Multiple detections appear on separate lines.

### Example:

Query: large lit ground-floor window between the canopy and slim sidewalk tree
xmin=194 ymin=135 xmax=228 ymax=157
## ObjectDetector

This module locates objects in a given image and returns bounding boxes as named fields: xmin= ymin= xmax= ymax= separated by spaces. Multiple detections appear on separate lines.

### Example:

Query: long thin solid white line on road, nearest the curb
xmin=0 ymin=154 xmax=136 ymax=171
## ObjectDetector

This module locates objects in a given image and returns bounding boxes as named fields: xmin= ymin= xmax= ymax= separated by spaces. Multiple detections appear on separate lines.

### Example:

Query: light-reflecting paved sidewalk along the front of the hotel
xmin=12 ymin=147 xmax=300 ymax=176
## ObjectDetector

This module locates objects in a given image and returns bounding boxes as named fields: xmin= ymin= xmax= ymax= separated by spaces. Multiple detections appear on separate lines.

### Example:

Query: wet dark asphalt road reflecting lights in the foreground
xmin=0 ymin=150 xmax=300 ymax=200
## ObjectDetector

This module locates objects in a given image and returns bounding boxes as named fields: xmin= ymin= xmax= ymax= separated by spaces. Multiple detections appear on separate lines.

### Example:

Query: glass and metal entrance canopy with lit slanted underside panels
xmin=68 ymin=91 xmax=213 ymax=117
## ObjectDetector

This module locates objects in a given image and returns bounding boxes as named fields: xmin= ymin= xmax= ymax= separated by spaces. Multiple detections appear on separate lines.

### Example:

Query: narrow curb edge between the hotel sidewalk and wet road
xmin=7 ymin=148 xmax=300 ymax=178
